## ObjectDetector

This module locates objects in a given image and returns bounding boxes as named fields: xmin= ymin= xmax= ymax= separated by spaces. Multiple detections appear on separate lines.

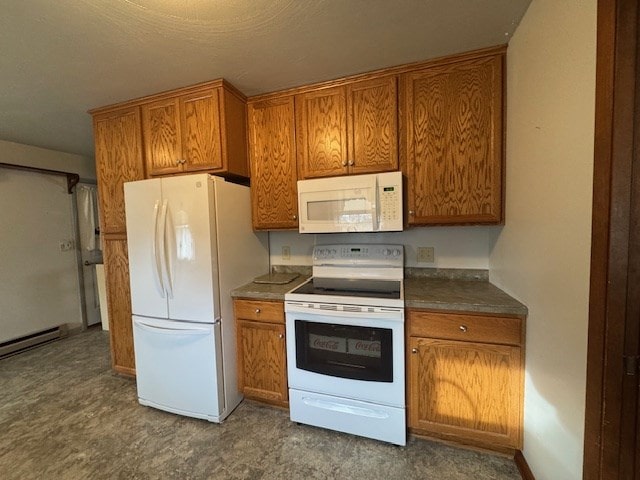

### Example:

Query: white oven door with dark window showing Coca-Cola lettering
xmin=286 ymin=302 xmax=405 ymax=407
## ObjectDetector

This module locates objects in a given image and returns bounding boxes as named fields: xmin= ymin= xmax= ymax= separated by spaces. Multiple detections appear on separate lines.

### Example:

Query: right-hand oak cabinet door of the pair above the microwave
xmin=347 ymin=76 xmax=398 ymax=173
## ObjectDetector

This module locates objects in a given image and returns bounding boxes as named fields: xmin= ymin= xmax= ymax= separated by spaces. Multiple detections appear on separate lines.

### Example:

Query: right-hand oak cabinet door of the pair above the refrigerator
xmin=179 ymin=89 xmax=223 ymax=172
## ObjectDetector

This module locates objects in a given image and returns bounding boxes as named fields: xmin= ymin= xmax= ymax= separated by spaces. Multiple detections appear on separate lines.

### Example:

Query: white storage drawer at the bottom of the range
xmin=289 ymin=389 xmax=407 ymax=445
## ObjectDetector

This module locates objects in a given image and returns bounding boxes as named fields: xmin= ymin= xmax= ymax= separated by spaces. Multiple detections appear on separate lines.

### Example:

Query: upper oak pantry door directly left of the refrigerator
xmin=93 ymin=107 xmax=144 ymax=233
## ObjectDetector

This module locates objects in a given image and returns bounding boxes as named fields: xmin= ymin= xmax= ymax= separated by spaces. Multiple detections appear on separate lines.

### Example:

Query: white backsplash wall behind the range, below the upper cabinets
xmin=269 ymin=226 xmax=501 ymax=270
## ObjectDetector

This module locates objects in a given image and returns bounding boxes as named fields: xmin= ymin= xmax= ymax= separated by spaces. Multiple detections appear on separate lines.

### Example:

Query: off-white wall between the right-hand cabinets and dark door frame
xmin=489 ymin=0 xmax=596 ymax=480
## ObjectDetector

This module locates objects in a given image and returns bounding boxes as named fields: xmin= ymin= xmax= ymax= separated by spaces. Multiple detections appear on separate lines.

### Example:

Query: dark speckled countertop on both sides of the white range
xmin=231 ymin=267 xmax=527 ymax=315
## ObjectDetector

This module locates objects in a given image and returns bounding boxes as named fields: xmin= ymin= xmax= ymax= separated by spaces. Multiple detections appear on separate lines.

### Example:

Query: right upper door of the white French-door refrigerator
xmin=162 ymin=174 xmax=220 ymax=322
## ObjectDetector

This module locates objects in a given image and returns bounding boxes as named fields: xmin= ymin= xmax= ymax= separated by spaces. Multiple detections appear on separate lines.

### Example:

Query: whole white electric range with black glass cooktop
xmin=285 ymin=244 xmax=406 ymax=445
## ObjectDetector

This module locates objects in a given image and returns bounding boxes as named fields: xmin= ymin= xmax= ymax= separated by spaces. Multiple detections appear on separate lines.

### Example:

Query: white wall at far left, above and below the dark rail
xmin=0 ymin=140 xmax=96 ymax=340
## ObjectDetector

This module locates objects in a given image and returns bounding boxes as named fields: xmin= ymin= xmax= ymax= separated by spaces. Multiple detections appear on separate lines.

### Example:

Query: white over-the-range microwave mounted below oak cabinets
xmin=298 ymin=172 xmax=403 ymax=233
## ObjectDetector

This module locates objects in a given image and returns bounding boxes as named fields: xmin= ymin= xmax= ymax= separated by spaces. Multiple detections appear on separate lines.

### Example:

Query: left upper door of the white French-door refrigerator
xmin=124 ymin=179 xmax=169 ymax=318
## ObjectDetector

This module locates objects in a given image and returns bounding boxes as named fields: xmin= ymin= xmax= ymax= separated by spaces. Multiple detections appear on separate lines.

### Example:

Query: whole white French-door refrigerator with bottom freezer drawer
xmin=124 ymin=174 xmax=269 ymax=422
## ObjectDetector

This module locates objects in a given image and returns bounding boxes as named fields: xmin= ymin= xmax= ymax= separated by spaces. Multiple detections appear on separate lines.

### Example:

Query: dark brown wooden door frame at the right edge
xmin=583 ymin=0 xmax=640 ymax=480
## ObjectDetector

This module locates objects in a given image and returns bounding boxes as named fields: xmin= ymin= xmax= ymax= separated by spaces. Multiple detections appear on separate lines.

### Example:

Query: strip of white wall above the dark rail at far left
xmin=0 ymin=140 xmax=96 ymax=181
